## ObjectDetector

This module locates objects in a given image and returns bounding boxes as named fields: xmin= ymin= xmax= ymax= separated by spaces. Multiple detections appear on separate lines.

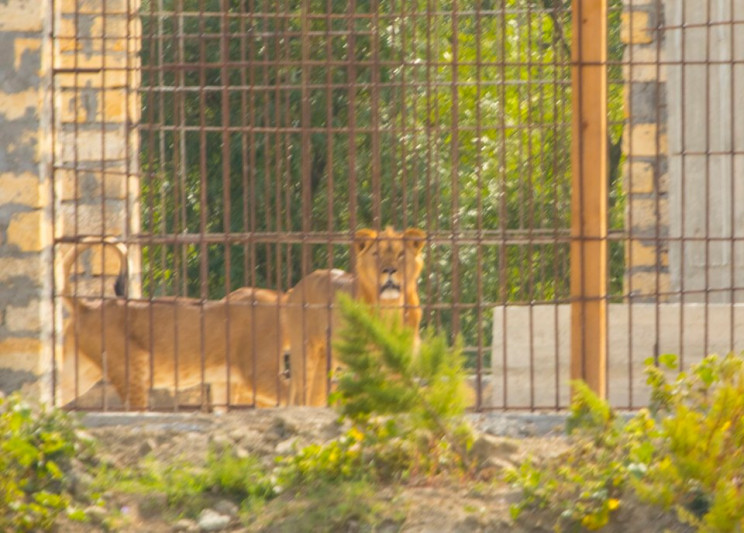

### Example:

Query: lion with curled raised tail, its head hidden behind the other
xmin=61 ymin=238 xmax=288 ymax=410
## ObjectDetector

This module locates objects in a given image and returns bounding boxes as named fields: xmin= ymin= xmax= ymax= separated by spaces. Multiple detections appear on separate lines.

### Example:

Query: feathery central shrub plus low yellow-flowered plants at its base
xmin=277 ymin=295 xmax=472 ymax=490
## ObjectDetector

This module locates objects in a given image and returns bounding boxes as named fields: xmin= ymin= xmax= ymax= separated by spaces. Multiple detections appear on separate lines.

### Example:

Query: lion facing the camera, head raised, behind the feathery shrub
xmin=285 ymin=227 xmax=426 ymax=406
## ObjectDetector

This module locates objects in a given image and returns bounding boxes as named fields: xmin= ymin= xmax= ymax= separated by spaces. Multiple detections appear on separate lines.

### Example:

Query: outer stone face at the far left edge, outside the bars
xmin=0 ymin=0 xmax=52 ymax=400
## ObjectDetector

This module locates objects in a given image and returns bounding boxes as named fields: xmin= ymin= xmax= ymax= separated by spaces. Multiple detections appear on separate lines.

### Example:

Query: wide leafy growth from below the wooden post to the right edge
xmin=508 ymin=355 xmax=744 ymax=531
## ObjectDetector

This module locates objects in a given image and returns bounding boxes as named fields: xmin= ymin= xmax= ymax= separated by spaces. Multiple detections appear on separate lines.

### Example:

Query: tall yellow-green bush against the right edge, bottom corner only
xmin=639 ymin=354 xmax=744 ymax=531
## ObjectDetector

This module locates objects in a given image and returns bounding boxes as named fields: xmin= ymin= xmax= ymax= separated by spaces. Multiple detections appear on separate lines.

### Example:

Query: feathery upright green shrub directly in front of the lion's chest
xmin=334 ymin=295 xmax=469 ymax=472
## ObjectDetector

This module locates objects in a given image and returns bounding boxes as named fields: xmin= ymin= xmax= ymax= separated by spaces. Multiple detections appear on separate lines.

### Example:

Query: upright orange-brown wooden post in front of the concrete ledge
xmin=571 ymin=0 xmax=607 ymax=398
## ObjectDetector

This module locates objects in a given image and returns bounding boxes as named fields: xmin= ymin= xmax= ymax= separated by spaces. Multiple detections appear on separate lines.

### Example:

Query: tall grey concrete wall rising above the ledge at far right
xmin=665 ymin=0 xmax=744 ymax=302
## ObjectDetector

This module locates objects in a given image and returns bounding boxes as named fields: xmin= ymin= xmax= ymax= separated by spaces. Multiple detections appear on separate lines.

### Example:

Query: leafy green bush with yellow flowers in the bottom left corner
xmin=0 ymin=394 xmax=91 ymax=531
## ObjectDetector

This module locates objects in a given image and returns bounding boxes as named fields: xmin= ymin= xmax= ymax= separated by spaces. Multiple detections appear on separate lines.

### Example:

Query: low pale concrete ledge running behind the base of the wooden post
xmin=492 ymin=303 xmax=744 ymax=409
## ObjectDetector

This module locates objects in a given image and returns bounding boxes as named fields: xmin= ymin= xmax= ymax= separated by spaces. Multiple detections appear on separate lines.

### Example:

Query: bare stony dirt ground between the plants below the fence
xmin=61 ymin=408 xmax=676 ymax=533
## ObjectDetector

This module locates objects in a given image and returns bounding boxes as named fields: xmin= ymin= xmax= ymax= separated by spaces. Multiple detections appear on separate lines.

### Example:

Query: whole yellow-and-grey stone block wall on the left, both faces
xmin=0 ymin=0 xmax=140 ymax=400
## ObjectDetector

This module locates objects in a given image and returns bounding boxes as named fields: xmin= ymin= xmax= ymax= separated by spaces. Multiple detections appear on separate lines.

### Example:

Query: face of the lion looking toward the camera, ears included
xmin=354 ymin=227 xmax=426 ymax=306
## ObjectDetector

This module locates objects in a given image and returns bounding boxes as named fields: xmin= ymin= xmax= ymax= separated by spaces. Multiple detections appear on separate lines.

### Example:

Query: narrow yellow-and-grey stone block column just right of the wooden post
xmin=621 ymin=0 xmax=670 ymax=301
